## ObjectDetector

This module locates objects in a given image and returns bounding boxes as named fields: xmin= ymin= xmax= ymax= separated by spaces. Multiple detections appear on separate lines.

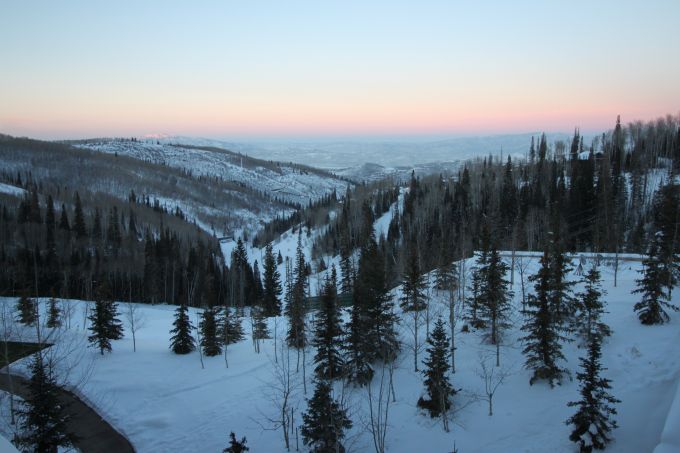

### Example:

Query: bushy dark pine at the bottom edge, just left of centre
xmin=301 ymin=379 xmax=352 ymax=453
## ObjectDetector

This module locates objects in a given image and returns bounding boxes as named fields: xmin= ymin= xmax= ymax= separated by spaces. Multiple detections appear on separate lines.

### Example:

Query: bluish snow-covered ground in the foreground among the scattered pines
xmin=0 ymin=256 xmax=680 ymax=453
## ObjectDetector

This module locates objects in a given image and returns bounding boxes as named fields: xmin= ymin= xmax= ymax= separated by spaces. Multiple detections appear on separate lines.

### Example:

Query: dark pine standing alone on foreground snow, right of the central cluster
xmin=418 ymin=318 xmax=455 ymax=418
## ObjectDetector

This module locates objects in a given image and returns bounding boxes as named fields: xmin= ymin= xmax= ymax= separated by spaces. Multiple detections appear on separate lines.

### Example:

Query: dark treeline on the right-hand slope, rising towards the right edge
xmin=314 ymin=116 xmax=680 ymax=285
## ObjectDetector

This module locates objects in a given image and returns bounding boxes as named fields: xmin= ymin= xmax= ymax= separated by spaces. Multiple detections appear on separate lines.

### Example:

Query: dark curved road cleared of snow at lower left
xmin=0 ymin=373 xmax=135 ymax=453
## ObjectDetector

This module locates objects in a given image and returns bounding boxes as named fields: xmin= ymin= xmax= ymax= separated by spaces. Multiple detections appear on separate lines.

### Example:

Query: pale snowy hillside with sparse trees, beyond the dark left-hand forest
xmin=75 ymin=139 xmax=348 ymax=206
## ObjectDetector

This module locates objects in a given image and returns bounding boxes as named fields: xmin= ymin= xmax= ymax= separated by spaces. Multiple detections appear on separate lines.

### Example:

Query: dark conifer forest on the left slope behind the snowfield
xmin=0 ymin=175 xmax=227 ymax=305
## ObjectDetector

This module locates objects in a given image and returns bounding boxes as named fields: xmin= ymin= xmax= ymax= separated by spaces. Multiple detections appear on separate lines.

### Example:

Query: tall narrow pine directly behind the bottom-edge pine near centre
xmin=312 ymin=267 xmax=343 ymax=380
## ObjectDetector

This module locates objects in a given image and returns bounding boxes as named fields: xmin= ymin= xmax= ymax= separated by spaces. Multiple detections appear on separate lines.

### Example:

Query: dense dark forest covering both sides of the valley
xmin=0 ymin=116 xmax=680 ymax=306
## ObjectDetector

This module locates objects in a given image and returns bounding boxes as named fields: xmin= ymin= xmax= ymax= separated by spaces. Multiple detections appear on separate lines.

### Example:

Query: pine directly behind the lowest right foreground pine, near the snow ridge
xmin=574 ymin=265 xmax=611 ymax=344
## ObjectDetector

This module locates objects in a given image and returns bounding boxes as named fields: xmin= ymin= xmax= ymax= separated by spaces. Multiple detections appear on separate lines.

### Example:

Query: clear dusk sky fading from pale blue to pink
xmin=0 ymin=0 xmax=680 ymax=139
